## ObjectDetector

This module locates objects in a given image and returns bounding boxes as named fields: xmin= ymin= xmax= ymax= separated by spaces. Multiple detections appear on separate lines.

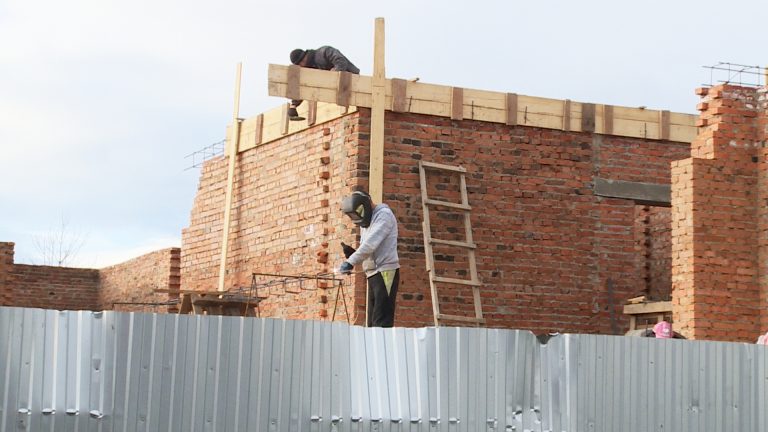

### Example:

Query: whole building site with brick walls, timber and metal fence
xmin=0 ymin=18 xmax=768 ymax=431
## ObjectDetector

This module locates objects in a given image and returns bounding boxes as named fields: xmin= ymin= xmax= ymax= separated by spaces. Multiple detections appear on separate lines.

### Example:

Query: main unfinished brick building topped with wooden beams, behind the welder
xmin=181 ymin=62 xmax=696 ymax=334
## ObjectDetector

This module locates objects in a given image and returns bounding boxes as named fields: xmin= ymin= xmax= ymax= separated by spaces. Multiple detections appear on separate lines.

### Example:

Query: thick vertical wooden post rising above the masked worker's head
xmin=368 ymin=18 xmax=386 ymax=203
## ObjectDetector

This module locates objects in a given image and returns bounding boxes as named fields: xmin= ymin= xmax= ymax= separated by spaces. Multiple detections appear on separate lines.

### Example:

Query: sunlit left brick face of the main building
xmin=181 ymin=114 xmax=368 ymax=323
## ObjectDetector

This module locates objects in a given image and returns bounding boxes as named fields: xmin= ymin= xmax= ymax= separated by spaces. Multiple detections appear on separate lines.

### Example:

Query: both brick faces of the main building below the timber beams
xmin=182 ymin=109 xmax=689 ymax=333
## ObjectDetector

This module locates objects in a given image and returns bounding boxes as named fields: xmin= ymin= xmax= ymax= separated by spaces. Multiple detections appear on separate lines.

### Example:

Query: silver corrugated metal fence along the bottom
xmin=0 ymin=308 xmax=768 ymax=432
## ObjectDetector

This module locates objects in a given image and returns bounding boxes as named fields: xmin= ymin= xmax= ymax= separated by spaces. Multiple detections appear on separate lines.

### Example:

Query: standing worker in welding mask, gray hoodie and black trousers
xmin=339 ymin=191 xmax=400 ymax=327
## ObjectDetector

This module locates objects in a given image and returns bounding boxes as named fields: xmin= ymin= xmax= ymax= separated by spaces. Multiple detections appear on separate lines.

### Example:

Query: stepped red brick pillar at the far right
xmin=672 ymin=85 xmax=764 ymax=342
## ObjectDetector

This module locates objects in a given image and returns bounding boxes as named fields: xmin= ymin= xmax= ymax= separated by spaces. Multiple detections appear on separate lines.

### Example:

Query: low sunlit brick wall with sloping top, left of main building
xmin=99 ymin=248 xmax=180 ymax=312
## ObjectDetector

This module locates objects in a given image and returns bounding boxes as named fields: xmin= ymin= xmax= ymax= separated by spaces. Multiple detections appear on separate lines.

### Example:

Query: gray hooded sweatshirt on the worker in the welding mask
xmin=347 ymin=203 xmax=400 ymax=277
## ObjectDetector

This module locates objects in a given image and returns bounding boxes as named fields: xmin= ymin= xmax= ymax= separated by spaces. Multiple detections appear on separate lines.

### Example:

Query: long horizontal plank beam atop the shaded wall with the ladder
xmin=269 ymin=64 xmax=697 ymax=143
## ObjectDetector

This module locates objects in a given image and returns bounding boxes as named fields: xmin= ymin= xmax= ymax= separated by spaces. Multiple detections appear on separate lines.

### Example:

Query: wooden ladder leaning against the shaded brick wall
xmin=419 ymin=161 xmax=485 ymax=327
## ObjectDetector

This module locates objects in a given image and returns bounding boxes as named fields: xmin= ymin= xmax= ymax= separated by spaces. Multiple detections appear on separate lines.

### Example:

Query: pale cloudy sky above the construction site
xmin=0 ymin=0 xmax=768 ymax=267
